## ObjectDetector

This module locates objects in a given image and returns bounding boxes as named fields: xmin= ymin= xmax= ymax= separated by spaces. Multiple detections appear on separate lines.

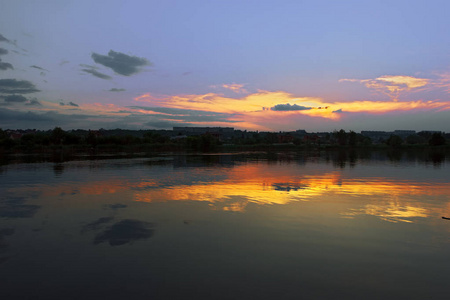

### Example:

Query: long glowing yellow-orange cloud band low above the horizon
xmin=131 ymin=86 xmax=450 ymax=130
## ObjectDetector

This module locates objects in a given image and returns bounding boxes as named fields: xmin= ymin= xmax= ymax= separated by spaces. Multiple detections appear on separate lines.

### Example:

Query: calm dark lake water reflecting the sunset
xmin=0 ymin=153 xmax=450 ymax=299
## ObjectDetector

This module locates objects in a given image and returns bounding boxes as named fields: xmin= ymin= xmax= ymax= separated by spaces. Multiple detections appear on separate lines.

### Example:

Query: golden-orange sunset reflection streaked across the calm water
xmin=5 ymin=157 xmax=450 ymax=222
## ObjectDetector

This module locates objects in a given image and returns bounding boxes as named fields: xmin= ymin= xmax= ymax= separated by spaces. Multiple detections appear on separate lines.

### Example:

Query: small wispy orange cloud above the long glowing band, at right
xmin=339 ymin=75 xmax=431 ymax=101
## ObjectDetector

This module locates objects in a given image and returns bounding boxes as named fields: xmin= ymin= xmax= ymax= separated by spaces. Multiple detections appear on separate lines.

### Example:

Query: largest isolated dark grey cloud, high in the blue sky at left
xmin=91 ymin=50 xmax=150 ymax=76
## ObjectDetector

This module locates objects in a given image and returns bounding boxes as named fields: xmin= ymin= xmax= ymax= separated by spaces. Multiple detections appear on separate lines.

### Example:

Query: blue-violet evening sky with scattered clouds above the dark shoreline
xmin=0 ymin=0 xmax=450 ymax=132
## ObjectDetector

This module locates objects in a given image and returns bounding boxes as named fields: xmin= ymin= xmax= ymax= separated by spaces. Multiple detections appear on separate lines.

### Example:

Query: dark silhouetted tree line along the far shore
xmin=0 ymin=127 xmax=449 ymax=151
